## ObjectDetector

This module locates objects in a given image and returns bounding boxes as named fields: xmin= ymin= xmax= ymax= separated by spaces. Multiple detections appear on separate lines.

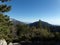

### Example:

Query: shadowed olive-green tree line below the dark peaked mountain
xmin=16 ymin=24 xmax=60 ymax=41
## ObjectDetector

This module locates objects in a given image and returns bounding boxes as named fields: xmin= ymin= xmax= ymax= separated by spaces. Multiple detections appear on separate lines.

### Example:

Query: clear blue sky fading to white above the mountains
xmin=8 ymin=0 xmax=60 ymax=25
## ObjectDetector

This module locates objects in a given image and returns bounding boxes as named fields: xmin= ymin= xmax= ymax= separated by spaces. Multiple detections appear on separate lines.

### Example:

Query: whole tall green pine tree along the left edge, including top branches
xmin=0 ymin=0 xmax=12 ymax=41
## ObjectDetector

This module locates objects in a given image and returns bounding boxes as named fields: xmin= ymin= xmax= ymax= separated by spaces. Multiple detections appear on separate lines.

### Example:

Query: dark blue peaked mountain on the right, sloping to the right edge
xmin=29 ymin=20 xmax=60 ymax=32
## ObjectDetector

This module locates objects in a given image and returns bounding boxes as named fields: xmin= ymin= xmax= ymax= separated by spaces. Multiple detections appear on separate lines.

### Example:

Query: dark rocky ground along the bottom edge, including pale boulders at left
xmin=0 ymin=39 xmax=60 ymax=45
